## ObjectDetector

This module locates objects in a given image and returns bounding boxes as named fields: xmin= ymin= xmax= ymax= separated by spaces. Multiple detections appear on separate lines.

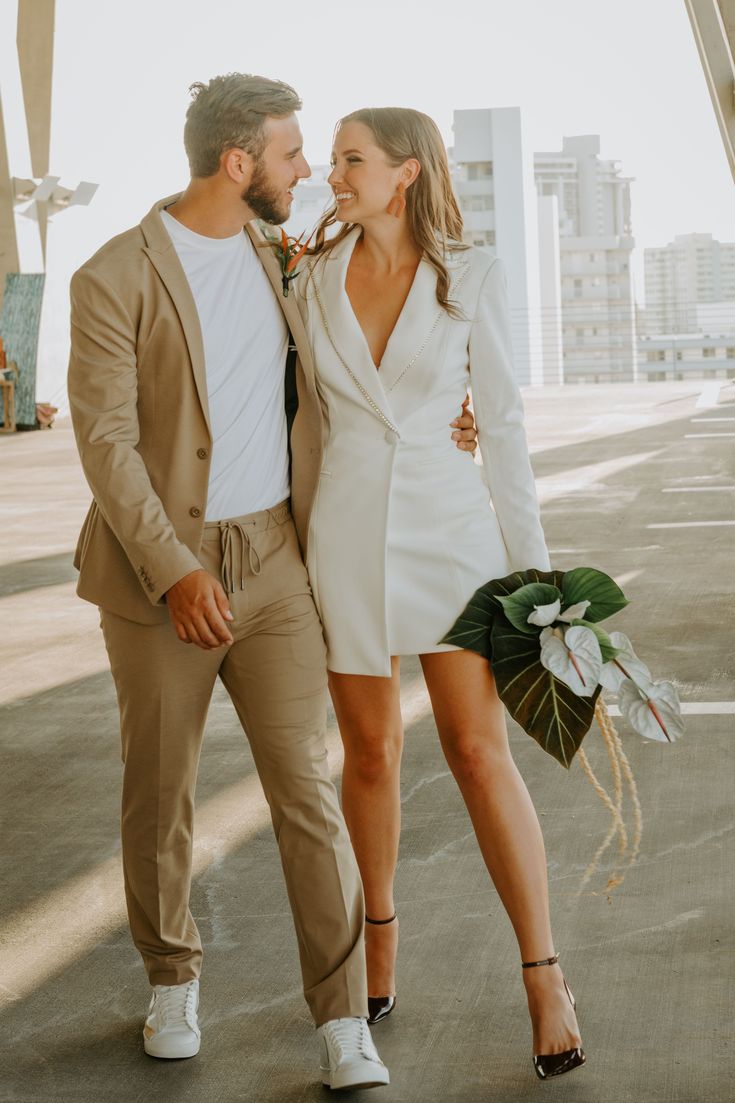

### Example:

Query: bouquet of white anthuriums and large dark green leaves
xmin=440 ymin=567 xmax=683 ymax=888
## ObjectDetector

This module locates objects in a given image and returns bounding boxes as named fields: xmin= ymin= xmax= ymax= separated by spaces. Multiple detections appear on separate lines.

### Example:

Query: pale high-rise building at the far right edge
xmin=643 ymin=234 xmax=735 ymax=336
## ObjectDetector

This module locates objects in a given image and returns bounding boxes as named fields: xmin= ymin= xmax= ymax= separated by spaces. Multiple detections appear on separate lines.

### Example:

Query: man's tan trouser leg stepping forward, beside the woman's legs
xmin=221 ymin=511 xmax=368 ymax=1026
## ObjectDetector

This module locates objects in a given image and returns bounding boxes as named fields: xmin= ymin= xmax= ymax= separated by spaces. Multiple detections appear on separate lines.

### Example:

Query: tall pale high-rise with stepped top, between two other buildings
xmin=534 ymin=135 xmax=637 ymax=383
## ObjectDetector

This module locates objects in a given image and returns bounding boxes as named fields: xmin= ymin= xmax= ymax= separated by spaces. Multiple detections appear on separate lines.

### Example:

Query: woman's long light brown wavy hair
xmin=309 ymin=107 xmax=467 ymax=317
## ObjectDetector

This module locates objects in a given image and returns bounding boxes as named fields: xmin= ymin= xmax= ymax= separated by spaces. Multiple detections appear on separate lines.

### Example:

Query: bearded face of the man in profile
xmin=243 ymin=115 xmax=311 ymax=225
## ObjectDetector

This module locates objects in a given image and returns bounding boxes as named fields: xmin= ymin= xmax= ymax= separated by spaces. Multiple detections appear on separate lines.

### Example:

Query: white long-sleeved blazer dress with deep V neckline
xmin=297 ymin=228 xmax=550 ymax=677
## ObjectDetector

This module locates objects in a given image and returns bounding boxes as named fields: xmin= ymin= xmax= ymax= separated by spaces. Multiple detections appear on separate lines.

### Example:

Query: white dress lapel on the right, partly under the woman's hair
xmin=380 ymin=254 xmax=468 ymax=393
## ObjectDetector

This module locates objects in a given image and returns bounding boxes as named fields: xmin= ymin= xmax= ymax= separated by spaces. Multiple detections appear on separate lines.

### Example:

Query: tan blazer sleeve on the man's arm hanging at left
xmin=68 ymin=268 xmax=201 ymax=604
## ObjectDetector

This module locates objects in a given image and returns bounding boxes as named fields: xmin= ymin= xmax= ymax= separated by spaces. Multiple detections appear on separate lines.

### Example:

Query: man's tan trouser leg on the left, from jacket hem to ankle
xmin=102 ymin=611 xmax=223 ymax=985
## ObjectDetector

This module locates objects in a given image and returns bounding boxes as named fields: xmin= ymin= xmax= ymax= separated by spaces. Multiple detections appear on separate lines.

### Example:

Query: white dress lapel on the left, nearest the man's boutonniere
xmin=306 ymin=228 xmax=392 ymax=420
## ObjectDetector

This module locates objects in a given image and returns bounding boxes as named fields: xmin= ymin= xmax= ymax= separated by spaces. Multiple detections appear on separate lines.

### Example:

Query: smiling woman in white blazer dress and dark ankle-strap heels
xmin=299 ymin=108 xmax=585 ymax=1079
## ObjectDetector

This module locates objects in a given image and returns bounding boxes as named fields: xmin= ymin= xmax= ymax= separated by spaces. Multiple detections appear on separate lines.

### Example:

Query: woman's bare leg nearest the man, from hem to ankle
xmin=329 ymin=657 xmax=403 ymax=996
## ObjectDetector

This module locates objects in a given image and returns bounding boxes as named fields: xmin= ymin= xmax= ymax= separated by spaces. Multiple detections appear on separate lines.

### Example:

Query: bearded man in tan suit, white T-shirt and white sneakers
xmin=68 ymin=74 xmax=473 ymax=1088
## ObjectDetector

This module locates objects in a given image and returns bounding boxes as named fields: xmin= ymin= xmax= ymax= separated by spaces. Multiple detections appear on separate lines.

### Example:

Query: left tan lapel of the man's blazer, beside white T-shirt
xmin=140 ymin=195 xmax=212 ymax=437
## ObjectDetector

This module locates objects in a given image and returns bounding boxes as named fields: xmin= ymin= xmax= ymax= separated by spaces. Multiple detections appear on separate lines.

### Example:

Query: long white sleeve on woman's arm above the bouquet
xmin=469 ymin=260 xmax=550 ymax=570
